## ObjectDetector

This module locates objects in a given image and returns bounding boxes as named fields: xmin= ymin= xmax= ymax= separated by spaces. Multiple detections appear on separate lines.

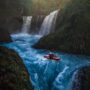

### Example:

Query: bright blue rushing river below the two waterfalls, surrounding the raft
xmin=1 ymin=34 xmax=90 ymax=90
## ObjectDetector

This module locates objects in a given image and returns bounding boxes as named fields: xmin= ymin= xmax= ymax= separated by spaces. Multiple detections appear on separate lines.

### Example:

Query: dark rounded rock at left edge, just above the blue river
xmin=0 ymin=28 xmax=12 ymax=42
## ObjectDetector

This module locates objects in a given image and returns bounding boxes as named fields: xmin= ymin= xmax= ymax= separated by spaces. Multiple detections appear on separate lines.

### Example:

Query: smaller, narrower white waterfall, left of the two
xmin=22 ymin=16 xmax=32 ymax=33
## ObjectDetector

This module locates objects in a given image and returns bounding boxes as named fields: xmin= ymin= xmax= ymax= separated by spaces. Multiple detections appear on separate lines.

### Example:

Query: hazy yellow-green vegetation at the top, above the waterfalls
xmin=29 ymin=0 xmax=70 ymax=15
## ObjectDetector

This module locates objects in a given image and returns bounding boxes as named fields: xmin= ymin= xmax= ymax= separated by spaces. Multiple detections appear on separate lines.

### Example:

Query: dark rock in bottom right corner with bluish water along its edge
xmin=72 ymin=67 xmax=90 ymax=90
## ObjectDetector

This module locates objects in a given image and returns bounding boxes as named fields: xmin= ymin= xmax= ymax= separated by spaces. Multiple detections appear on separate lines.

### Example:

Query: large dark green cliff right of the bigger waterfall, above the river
xmin=34 ymin=0 xmax=90 ymax=54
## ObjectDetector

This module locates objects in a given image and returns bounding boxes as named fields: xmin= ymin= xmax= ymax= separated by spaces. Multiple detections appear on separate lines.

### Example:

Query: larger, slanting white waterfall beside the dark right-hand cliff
xmin=39 ymin=10 xmax=59 ymax=35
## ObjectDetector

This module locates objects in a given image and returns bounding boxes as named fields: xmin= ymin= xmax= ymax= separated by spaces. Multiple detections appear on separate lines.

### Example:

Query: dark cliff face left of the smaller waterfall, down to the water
xmin=0 ymin=0 xmax=23 ymax=42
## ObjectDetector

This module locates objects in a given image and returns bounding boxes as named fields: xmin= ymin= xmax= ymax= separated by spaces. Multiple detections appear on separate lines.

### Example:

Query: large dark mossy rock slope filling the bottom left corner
xmin=0 ymin=46 xmax=33 ymax=90
